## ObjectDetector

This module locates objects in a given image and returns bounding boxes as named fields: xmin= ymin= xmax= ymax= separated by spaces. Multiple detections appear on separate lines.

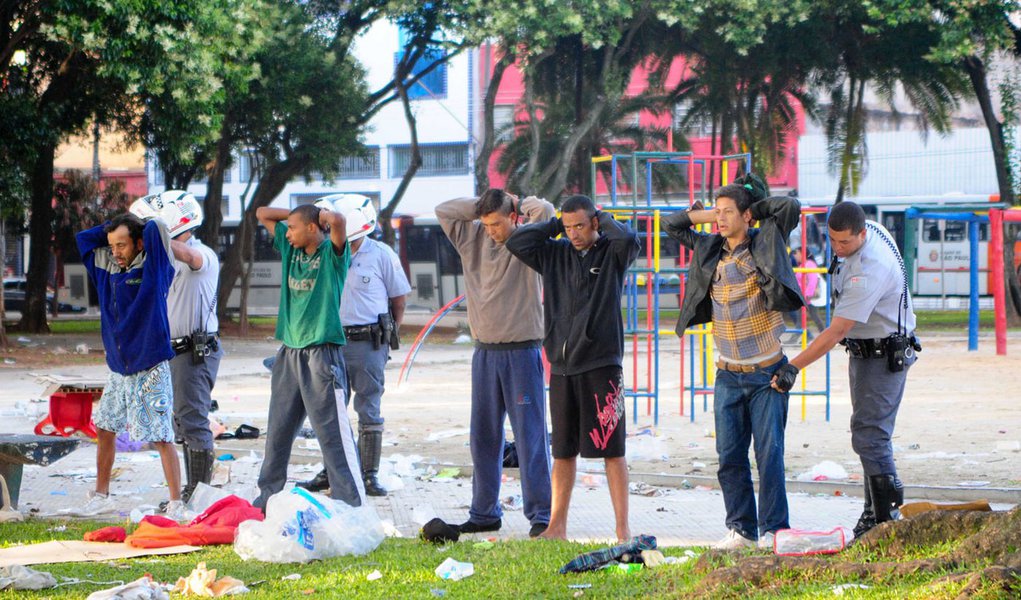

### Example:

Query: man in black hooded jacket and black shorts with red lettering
xmin=506 ymin=196 xmax=641 ymax=541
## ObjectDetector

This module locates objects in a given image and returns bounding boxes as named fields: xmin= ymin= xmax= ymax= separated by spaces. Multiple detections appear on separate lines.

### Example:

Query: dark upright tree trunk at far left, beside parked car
xmin=19 ymin=143 xmax=56 ymax=334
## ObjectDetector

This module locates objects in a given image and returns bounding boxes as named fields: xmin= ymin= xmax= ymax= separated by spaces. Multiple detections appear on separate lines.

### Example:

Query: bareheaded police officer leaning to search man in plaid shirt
xmin=773 ymin=201 xmax=921 ymax=537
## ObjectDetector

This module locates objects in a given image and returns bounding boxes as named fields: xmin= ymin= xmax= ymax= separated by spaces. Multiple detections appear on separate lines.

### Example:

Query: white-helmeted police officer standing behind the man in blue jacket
xmin=132 ymin=190 xmax=224 ymax=502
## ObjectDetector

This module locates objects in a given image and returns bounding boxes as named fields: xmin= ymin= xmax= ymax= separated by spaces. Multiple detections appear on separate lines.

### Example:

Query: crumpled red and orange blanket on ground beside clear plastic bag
xmin=125 ymin=495 xmax=264 ymax=548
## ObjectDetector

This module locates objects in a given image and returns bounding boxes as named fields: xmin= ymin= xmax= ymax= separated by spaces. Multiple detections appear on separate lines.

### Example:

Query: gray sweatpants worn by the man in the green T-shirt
xmin=254 ymin=344 xmax=366 ymax=509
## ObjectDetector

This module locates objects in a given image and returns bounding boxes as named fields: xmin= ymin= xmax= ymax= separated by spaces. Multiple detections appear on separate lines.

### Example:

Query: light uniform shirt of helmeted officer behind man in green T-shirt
xmin=340 ymin=238 xmax=411 ymax=327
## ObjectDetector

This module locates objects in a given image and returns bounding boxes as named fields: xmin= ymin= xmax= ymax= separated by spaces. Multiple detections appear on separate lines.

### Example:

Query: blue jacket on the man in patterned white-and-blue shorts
xmin=76 ymin=219 xmax=174 ymax=376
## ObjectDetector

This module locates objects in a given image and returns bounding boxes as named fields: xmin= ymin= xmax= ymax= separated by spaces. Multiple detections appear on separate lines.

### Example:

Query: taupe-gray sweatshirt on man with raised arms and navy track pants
xmin=436 ymin=197 xmax=554 ymax=344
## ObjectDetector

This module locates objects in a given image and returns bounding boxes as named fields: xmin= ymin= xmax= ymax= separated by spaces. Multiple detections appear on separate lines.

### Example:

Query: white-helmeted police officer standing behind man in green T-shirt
xmin=298 ymin=194 xmax=411 ymax=496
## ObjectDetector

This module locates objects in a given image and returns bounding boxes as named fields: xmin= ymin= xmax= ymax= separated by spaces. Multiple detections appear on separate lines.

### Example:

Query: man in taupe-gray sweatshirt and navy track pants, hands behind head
xmin=436 ymin=189 xmax=553 ymax=538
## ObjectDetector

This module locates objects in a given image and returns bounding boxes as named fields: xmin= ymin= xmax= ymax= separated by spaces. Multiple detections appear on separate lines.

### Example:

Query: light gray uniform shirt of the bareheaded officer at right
xmin=833 ymin=220 xmax=915 ymax=339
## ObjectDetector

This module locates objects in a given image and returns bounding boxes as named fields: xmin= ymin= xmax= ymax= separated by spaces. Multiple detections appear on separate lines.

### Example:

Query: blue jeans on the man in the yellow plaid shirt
xmin=714 ymin=357 xmax=790 ymax=540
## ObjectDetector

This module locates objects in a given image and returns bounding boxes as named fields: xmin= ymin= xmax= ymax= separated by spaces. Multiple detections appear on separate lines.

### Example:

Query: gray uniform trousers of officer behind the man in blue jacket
xmin=171 ymin=347 xmax=224 ymax=450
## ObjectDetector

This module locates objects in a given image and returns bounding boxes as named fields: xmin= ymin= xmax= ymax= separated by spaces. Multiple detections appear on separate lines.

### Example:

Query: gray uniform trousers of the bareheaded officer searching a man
xmin=847 ymin=358 xmax=916 ymax=477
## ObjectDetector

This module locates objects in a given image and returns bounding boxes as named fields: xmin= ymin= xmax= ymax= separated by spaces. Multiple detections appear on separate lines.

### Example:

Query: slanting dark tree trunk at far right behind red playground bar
xmin=964 ymin=56 xmax=1021 ymax=320
